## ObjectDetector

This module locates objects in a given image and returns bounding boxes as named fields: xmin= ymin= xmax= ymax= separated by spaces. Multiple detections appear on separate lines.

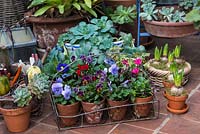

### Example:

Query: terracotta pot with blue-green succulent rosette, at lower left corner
xmin=0 ymin=85 xmax=32 ymax=132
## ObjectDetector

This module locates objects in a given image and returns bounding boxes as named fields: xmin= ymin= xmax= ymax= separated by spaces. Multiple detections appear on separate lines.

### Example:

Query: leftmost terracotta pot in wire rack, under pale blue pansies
xmin=57 ymin=102 xmax=80 ymax=126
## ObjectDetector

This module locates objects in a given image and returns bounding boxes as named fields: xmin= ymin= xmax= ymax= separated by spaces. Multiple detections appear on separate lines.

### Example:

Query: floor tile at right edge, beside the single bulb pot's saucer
xmin=181 ymin=103 xmax=200 ymax=123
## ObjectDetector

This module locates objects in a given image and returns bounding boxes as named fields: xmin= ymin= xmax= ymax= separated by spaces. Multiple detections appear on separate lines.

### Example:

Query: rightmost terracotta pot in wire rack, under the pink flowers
xmin=134 ymin=96 xmax=153 ymax=117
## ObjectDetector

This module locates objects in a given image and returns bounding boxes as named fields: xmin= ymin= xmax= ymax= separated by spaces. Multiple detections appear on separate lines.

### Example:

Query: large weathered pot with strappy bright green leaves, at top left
xmin=26 ymin=0 xmax=101 ymax=56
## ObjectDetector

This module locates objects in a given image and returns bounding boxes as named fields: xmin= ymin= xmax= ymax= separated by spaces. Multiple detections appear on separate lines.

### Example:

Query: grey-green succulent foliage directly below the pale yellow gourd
xmin=28 ymin=73 xmax=50 ymax=99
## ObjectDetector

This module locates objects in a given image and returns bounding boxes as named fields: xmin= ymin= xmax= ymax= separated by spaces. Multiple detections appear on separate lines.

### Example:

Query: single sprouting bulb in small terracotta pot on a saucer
xmin=165 ymin=69 xmax=189 ymax=114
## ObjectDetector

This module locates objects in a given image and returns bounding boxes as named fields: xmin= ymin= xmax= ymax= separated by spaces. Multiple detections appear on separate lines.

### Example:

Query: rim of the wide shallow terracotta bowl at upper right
xmin=143 ymin=20 xmax=193 ymax=27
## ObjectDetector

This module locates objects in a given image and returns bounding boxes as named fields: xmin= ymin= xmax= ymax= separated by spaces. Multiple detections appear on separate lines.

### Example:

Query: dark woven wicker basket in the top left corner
xmin=0 ymin=0 xmax=25 ymax=28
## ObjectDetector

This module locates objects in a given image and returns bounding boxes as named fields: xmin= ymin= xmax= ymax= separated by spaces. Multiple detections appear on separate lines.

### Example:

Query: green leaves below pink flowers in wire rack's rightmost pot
xmin=129 ymin=76 xmax=152 ymax=100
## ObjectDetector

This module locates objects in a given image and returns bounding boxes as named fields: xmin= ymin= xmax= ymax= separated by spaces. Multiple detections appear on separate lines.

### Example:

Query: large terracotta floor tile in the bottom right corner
xmin=160 ymin=116 xmax=200 ymax=134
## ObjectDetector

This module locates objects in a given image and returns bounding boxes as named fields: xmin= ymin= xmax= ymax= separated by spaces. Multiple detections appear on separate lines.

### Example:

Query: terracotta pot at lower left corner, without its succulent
xmin=0 ymin=105 xmax=31 ymax=133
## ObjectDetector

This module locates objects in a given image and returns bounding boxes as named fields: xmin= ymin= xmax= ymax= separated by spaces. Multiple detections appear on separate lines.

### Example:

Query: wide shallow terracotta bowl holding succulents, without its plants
xmin=143 ymin=21 xmax=198 ymax=38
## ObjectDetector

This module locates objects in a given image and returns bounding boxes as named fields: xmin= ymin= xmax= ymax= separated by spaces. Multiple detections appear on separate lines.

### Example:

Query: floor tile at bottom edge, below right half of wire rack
xmin=111 ymin=124 xmax=153 ymax=134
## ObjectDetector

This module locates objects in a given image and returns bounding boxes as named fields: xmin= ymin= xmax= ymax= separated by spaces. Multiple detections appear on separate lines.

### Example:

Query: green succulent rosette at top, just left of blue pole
xmin=110 ymin=5 xmax=137 ymax=24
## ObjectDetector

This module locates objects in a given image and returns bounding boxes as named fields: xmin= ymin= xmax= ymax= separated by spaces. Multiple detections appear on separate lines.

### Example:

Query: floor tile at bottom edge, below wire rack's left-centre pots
xmin=73 ymin=125 xmax=114 ymax=134
